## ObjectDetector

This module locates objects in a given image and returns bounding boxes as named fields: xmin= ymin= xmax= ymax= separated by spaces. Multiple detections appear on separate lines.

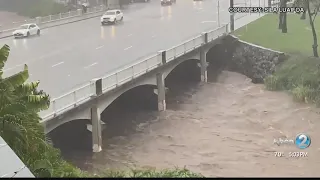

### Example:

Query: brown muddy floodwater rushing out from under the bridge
xmin=50 ymin=71 xmax=320 ymax=177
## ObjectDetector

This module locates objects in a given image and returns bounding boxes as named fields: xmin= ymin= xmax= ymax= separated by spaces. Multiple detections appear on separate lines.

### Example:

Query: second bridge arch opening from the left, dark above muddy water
xmin=101 ymin=85 xmax=158 ymax=139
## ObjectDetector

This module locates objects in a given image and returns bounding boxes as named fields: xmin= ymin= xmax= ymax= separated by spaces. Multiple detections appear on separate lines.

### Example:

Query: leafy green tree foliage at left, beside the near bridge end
xmin=0 ymin=45 xmax=85 ymax=177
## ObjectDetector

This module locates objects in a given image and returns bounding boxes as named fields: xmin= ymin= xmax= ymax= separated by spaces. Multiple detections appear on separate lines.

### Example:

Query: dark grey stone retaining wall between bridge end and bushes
xmin=209 ymin=35 xmax=287 ymax=83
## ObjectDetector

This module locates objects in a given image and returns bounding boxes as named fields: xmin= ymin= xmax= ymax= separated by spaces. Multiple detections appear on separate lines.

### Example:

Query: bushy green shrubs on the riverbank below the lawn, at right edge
xmin=264 ymin=54 xmax=320 ymax=105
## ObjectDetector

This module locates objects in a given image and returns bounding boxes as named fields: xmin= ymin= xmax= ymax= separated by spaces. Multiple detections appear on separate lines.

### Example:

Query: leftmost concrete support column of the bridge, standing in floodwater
xmin=91 ymin=79 xmax=102 ymax=152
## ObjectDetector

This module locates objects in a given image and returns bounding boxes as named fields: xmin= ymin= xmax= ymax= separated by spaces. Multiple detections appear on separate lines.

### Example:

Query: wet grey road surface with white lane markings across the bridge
xmin=0 ymin=0 xmax=258 ymax=97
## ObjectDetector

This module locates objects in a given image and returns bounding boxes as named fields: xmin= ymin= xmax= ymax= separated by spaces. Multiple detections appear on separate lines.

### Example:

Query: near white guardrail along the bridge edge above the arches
xmin=40 ymin=25 xmax=228 ymax=121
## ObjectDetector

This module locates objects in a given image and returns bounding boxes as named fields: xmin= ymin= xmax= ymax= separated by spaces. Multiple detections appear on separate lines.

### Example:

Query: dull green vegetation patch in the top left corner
xmin=0 ymin=0 xmax=68 ymax=18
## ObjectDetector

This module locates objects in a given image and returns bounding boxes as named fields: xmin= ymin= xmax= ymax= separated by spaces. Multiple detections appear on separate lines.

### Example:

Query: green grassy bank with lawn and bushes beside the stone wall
xmin=234 ymin=14 xmax=320 ymax=105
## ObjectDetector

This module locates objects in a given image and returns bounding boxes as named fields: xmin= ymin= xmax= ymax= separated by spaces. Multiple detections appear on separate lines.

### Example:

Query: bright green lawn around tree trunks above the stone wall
xmin=234 ymin=14 xmax=320 ymax=56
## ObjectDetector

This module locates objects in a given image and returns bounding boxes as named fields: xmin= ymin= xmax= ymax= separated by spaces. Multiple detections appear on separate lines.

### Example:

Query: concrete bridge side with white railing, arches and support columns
xmin=41 ymin=25 xmax=228 ymax=152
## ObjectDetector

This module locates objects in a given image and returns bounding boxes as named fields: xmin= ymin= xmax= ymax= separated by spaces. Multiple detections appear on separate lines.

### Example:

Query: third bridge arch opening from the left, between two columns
xmin=165 ymin=59 xmax=201 ymax=109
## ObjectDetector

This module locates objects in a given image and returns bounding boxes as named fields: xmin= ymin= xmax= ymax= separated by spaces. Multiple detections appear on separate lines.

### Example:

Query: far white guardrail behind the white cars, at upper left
xmin=0 ymin=5 xmax=107 ymax=33
